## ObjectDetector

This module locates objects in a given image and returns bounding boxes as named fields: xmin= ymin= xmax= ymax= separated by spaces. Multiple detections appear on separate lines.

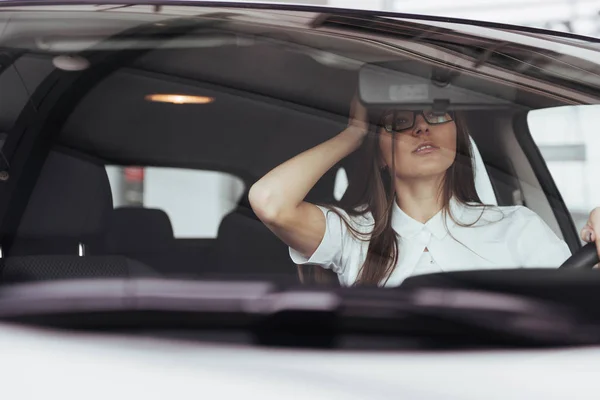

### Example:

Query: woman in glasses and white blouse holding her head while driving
xmin=249 ymin=99 xmax=600 ymax=286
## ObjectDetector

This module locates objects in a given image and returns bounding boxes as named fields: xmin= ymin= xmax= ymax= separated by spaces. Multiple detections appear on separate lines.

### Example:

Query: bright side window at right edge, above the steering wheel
xmin=527 ymin=106 xmax=600 ymax=238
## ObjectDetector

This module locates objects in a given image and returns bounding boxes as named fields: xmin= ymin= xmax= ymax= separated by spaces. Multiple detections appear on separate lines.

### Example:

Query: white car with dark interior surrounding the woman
xmin=0 ymin=1 xmax=600 ymax=399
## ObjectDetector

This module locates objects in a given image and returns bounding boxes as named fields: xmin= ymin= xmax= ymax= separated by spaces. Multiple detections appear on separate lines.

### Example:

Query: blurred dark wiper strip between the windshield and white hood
xmin=0 ymin=279 xmax=600 ymax=347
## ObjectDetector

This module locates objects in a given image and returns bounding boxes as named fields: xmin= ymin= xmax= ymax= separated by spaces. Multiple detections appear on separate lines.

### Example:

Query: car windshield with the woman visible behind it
xmin=0 ymin=2 xmax=600 ymax=346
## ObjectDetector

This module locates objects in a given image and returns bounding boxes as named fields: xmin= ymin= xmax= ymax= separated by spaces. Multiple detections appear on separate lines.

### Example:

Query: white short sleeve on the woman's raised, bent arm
xmin=290 ymin=206 xmax=350 ymax=274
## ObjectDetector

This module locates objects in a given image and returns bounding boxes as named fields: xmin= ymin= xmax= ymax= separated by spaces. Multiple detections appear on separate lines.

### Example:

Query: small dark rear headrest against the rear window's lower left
xmin=106 ymin=207 xmax=174 ymax=254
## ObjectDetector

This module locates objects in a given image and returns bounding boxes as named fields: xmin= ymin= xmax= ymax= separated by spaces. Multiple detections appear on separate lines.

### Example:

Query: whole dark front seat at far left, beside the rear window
xmin=0 ymin=151 xmax=156 ymax=282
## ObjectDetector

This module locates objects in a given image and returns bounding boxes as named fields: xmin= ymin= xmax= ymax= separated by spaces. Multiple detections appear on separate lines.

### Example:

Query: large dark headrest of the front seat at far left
xmin=17 ymin=151 xmax=113 ymax=238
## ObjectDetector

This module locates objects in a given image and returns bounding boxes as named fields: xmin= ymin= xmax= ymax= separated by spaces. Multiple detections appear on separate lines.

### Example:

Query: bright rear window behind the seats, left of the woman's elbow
xmin=106 ymin=166 xmax=244 ymax=239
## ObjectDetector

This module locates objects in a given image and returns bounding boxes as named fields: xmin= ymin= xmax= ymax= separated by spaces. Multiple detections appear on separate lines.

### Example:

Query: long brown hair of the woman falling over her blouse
xmin=299 ymin=113 xmax=483 ymax=286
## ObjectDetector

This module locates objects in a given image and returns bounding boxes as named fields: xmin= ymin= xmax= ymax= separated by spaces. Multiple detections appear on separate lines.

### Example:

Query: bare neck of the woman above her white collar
xmin=396 ymin=176 xmax=444 ymax=223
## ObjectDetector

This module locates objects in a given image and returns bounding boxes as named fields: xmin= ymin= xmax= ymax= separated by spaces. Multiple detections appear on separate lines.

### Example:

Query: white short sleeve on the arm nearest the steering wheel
xmin=513 ymin=207 xmax=571 ymax=268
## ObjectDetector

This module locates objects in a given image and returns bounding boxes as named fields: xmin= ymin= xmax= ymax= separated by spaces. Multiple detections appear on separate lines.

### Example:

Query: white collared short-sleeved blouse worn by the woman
xmin=290 ymin=199 xmax=571 ymax=286
